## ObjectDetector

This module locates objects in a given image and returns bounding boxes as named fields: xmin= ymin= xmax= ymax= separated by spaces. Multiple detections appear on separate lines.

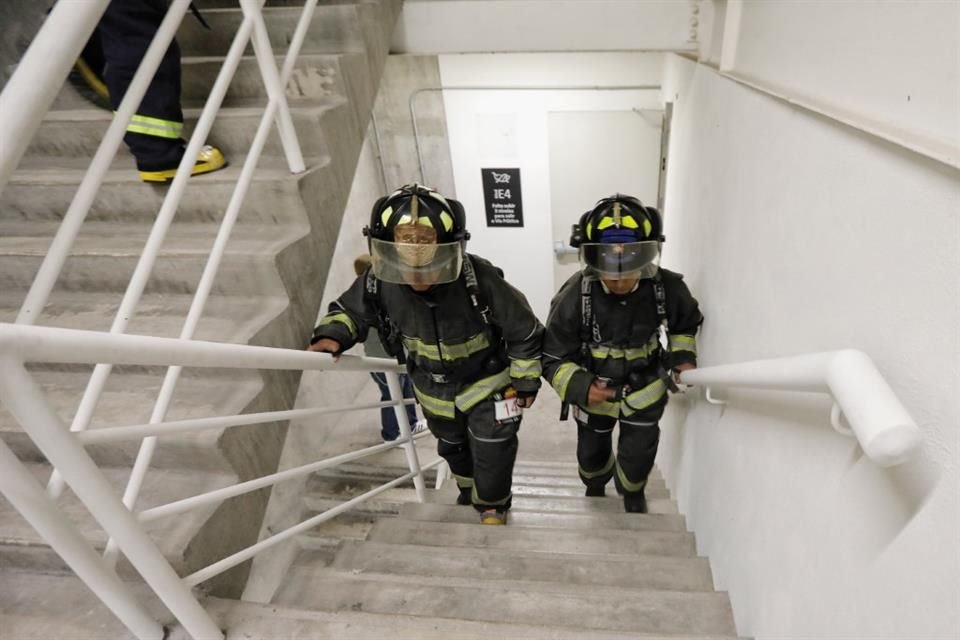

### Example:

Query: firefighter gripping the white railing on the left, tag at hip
xmin=310 ymin=184 xmax=543 ymax=524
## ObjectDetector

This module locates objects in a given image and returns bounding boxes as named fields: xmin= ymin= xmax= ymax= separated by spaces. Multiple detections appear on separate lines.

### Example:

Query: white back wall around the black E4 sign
xmin=438 ymin=53 xmax=663 ymax=319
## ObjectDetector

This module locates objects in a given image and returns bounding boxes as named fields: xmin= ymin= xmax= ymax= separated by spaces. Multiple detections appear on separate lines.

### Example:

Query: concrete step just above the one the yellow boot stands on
xmin=27 ymin=99 xmax=349 ymax=162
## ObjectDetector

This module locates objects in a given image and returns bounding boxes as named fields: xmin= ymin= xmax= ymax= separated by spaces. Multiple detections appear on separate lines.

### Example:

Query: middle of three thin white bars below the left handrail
xmin=137 ymin=431 xmax=428 ymax=522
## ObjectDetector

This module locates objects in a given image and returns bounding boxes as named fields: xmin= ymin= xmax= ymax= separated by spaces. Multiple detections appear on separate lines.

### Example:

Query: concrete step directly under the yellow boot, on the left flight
xmin=0 ymin=152 xmax=331 ymax=226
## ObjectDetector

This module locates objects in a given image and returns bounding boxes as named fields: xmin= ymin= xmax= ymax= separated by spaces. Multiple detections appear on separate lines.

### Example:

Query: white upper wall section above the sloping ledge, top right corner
xmin=716 ymin=0 xmax=960 ymax=166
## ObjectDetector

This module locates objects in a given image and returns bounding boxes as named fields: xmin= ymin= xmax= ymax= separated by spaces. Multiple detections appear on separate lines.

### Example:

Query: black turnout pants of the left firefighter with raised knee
xmin=427 ymin=398 xmax=521 ymax=512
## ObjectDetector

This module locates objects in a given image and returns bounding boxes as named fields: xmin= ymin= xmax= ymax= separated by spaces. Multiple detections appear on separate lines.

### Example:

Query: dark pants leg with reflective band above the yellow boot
xmin=97 ymin=0 xmax=183 ymax=171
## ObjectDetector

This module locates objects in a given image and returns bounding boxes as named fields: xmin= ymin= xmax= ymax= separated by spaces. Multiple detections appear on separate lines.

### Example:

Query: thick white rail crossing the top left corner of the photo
xmin=0 ymin=0 xmax=110 ymax=192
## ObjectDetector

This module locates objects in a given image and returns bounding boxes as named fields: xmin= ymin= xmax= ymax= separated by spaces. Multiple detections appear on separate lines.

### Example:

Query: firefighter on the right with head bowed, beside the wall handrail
xmin=543 ymin=194 xmax=703 ymax=513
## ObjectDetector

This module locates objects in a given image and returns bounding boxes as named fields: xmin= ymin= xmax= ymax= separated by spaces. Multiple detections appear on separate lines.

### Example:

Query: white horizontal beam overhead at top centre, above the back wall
xmin=390 ymin=0 xmax=699 ymax=53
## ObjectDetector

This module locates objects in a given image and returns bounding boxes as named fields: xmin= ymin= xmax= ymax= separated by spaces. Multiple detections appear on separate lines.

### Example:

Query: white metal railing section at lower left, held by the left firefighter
xmin=0 ymin=323 xmax=424 ymax=640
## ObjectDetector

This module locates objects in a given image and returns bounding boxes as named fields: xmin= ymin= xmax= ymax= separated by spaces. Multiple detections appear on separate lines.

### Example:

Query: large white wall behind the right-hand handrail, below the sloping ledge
xmin=659 ymin=53 xmax=960 ymax=640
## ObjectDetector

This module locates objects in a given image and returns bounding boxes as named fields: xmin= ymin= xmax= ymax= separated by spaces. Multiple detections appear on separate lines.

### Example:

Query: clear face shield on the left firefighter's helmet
xmin=370 ymin=238 xmax=463 ymax=285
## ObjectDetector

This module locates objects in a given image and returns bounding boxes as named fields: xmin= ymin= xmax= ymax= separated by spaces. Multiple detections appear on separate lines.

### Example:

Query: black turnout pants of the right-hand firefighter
xmin=576 ymin=395 xmax=667 ymax=496
